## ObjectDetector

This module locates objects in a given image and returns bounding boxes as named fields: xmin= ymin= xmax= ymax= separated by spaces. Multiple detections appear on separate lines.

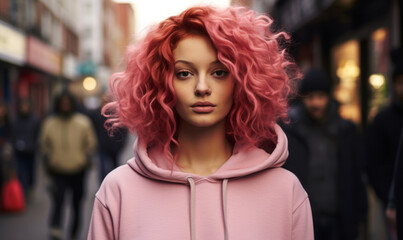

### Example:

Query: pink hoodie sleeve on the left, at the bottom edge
xmin=87 ymin=197 xmax=116 ymax=240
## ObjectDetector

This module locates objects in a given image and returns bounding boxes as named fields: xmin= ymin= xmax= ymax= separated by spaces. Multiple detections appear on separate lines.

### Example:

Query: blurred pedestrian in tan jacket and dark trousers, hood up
xmin=40 ymin=91 xmax=96 ymax=239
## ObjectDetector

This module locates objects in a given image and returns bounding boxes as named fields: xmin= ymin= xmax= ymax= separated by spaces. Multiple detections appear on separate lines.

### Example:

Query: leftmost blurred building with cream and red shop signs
xmin=0 ymin=0 xmax=78 ymax=117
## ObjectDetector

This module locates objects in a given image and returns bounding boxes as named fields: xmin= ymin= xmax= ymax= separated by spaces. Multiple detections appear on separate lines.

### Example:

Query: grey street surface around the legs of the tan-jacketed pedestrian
xmin=0 ymin=136 xmax=134 ymax=240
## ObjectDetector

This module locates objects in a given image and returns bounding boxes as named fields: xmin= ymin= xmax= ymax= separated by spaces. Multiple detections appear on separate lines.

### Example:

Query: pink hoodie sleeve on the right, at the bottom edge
xmin=291 ymin=197 xmax=314 ymax=240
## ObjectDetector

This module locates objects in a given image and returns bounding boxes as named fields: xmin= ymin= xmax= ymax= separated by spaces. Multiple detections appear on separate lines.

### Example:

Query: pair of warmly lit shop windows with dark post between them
xmin=331 ymin=26 xmax=392 ymax=126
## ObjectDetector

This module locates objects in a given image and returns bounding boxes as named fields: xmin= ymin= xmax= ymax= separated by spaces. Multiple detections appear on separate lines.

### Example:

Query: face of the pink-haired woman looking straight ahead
xmin=173 ymin=35 xmax=234 ymax=127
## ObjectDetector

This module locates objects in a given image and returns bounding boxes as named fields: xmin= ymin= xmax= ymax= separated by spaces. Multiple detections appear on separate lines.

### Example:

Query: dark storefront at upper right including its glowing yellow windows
xmin=271 ymin=0 xmax=402 ymax=129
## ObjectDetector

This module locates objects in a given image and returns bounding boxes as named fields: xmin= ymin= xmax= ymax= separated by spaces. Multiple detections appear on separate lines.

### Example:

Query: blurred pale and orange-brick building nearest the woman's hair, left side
xmin=74 ymin=0 xmax=134 ymax=108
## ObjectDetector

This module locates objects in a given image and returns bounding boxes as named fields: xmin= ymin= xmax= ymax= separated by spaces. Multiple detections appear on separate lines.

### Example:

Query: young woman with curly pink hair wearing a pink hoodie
xmin=88 ymin=7 xmax=313 ymax=240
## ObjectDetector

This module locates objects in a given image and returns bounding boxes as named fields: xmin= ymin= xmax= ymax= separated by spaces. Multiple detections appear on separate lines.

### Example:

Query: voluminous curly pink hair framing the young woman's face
xmin=103 ymin=7 xmax=299 ymax=161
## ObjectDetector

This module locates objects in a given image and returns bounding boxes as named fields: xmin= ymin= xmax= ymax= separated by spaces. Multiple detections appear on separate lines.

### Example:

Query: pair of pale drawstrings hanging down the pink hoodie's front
xmin=187 ymin=176 xmax=228 ymax=240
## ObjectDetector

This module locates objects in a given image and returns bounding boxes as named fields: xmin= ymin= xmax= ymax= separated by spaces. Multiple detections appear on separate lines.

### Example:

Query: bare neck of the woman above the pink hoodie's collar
xmin=178 ymin=121 xmax=232 ymax=176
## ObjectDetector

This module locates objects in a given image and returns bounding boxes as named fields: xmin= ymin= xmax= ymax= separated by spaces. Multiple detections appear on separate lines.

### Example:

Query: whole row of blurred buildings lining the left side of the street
xmin=0 ymin=0 xmax=133 ymax=117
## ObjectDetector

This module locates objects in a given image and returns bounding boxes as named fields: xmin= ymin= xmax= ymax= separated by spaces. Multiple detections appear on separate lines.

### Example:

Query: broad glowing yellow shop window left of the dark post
xmin=333 ymin=40 xmax=361 ymax=124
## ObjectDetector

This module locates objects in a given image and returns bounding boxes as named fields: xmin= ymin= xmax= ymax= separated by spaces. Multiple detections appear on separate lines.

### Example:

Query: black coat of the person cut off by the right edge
xmin=366 ymin=104 xmax=403 ymax=207
